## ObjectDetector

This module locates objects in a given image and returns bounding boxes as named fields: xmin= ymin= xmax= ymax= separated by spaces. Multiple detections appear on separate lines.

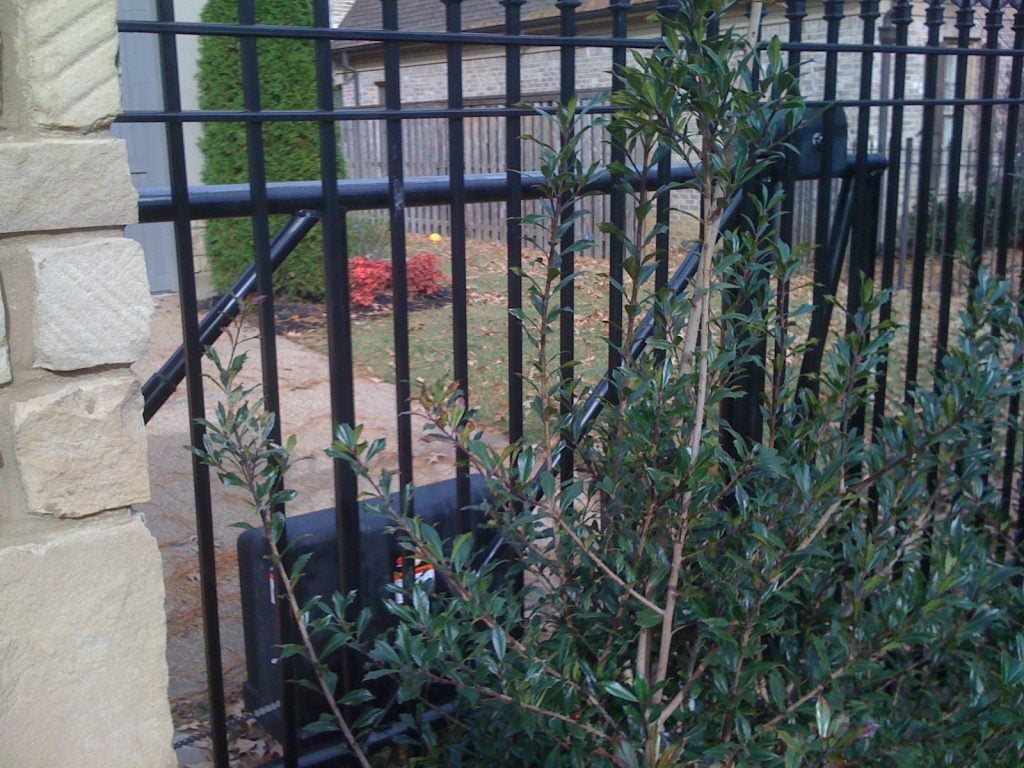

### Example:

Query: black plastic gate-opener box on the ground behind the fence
xmin=238 ymin=475 xmax=496 ymax=737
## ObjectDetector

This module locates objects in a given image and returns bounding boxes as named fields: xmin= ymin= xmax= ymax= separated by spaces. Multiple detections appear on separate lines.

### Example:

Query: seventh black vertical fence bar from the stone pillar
xmin=555 ymin=0 xmax=582 ymax=482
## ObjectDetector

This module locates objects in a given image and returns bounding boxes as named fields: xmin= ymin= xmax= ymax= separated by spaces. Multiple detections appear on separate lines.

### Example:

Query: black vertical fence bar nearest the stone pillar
xmin=157 ymin=0 xmax=230 ymax=768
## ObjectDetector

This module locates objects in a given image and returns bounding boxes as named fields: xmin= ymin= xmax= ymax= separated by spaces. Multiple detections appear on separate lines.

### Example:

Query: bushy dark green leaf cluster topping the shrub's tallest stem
xmin=611 ymin=0 xmax=803 ymax=207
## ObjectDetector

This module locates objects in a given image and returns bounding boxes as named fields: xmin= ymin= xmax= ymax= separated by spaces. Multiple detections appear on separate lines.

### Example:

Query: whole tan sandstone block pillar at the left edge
xmin=0 ymin=0 xmax=176 ymax=768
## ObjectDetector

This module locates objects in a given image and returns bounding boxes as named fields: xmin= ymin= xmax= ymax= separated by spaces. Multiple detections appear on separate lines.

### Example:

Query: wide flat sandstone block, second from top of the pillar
xmin=0 ymin=138 xmax=138 ymax=234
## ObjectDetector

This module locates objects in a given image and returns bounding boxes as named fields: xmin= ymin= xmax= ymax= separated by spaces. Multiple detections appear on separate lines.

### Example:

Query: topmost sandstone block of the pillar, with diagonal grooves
xmin=14 ymin=0 xmax=121 ymax=130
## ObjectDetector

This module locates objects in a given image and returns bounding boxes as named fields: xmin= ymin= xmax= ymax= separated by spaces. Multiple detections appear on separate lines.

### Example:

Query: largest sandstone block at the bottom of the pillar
xmin=0 ymin=516 xmax=177 ymax=768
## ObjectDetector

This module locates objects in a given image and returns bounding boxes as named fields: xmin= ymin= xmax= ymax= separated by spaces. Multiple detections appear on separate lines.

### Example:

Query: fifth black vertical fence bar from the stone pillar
xmin=441 ymin=0 xmax=470 ymax=532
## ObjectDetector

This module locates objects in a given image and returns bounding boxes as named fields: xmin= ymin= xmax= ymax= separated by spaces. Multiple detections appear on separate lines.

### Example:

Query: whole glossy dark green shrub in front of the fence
xmin=195 ymin=0 xmax=1024 ymax=768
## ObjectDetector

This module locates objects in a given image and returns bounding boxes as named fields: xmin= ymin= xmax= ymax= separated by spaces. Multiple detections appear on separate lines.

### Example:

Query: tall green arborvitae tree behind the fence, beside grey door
xmin=198 ymin=0 xmax=344 ymax=300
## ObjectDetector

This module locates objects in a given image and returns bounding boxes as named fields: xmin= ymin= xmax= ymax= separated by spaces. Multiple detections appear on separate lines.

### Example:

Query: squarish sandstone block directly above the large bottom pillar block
xmin=11 ymin=374 xmax=150 ymax=517
